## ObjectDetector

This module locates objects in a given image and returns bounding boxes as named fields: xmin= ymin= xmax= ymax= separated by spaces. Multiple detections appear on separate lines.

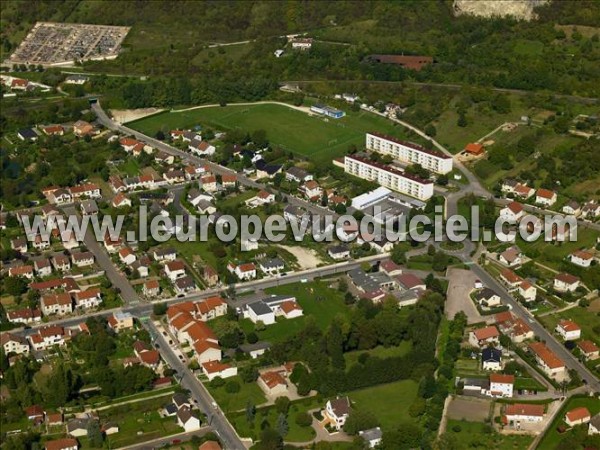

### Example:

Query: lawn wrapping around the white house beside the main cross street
xmin=240 ymin=281 xmax=350 ymax=342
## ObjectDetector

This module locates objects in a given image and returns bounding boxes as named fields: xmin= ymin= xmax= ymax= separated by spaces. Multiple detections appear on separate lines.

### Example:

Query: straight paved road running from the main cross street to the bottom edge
xmin=144 ymin=320 xmax=246 ymax=450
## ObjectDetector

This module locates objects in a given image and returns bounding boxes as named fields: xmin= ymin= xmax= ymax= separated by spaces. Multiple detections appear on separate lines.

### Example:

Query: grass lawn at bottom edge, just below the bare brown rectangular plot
xmin=446 ymin=420 xmax=533 ymax=450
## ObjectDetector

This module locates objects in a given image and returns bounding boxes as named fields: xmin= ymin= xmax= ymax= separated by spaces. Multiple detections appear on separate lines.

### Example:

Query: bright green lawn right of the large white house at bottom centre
xmin=348 ymin=380 xmax=418 ymax=431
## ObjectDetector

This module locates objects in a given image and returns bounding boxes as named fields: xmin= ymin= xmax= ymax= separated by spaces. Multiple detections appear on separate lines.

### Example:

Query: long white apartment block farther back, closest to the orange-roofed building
xmin=366 ymin=132 xmax=452 ymax=174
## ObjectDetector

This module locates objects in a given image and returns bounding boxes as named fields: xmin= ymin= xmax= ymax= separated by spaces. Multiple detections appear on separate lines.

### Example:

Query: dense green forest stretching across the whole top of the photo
xmin=1 ymin=1 xmax=600 ymax=99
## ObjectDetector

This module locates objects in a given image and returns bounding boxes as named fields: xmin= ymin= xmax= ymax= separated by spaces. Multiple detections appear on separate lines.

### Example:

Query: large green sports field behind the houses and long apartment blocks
xmin=127 ymin=104 xmax=418 ymax=162
